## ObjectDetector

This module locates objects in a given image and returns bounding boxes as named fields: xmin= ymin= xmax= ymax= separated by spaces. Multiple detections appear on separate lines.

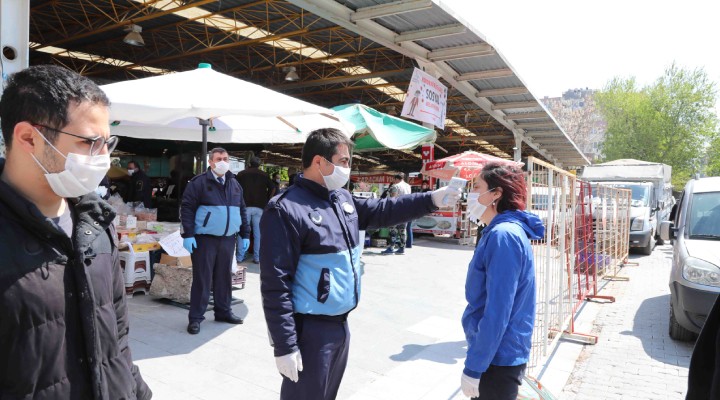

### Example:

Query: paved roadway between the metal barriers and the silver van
xmin=560 ymin=245 xmax=693 ymax=400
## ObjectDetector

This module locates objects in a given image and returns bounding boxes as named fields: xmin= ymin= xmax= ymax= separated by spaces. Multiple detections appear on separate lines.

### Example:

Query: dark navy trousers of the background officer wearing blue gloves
xmin=188 ymin=235 xmax=235 ymax=322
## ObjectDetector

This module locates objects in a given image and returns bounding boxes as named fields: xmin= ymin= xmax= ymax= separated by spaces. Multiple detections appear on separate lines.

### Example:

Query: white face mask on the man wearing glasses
xmin=30 ymin=129 xmax=110 ymax=198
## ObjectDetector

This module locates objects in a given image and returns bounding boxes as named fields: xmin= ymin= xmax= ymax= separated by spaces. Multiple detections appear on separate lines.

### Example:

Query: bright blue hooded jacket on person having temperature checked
xmin=462 ymin=211 xmax=545 ymax=378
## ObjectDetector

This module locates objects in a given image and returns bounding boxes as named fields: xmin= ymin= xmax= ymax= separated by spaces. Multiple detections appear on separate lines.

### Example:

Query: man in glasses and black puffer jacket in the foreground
xmin=0 ymin=66 xmax=152 ymax=400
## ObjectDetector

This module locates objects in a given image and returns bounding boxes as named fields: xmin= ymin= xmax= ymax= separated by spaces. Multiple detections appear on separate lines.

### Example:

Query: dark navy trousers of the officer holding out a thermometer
xmin=280 ymin=316 xmax=350 ymax=400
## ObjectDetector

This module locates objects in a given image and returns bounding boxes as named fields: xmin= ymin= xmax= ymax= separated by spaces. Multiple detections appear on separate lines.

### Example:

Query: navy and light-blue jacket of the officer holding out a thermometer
xmin=260 ymin=176 xmax=436 ymax=356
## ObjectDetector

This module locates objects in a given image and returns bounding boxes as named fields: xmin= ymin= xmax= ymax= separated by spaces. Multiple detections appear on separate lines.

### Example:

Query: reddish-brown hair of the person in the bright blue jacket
xmin=480 ymin=163 xmax=527 ymax=213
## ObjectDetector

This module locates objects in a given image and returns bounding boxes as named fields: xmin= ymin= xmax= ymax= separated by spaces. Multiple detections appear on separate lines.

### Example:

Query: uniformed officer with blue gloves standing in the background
xmin=180 ymin=147 xmax=250 ymax=335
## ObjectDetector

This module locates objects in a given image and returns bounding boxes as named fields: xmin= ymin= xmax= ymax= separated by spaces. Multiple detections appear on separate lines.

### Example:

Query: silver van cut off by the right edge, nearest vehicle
xmin=660 ymin=177 xmax=720 ymax=341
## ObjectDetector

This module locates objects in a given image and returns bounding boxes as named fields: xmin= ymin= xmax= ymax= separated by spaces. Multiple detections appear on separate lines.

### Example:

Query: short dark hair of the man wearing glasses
xmin=0 ymin=65 xmax=110 ymax=148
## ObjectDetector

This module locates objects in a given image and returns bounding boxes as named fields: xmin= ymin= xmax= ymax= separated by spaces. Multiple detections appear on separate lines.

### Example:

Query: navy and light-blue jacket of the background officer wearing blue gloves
xmin=180 ymin=168 xmax=250 ymax=239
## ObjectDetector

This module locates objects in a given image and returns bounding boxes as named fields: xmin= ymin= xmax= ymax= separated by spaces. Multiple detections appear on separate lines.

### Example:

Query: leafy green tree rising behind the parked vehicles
xmin=596 ymin=64 xmax=718 ymax=187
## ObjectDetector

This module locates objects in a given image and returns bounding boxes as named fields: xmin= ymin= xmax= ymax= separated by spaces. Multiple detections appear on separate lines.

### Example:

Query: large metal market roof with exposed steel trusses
xmin=30 ymin=0 xmax=588 ymax=171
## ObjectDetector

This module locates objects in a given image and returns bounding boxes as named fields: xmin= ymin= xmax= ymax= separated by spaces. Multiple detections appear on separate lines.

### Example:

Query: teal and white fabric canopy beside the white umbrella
xmin=332 ymin=104 xmax=437 ymax=152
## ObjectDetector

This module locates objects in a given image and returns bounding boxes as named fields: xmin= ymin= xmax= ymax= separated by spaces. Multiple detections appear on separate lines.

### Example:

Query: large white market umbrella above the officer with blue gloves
xmin=101 ymin=64 xmax=353 ymax=170
